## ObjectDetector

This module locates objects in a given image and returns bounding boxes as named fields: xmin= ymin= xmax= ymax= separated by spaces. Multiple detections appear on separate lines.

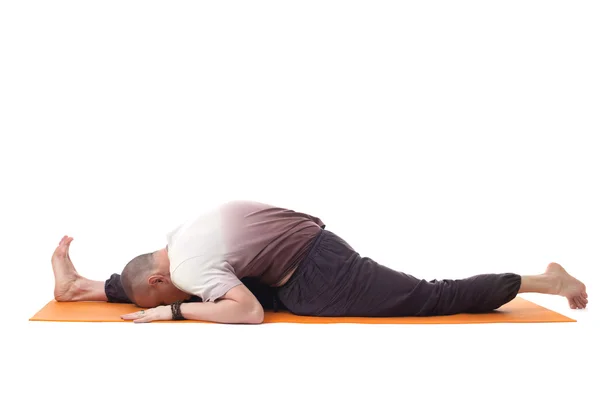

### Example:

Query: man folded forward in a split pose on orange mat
xmin=52 ymin=201 xmax=588 ymax=324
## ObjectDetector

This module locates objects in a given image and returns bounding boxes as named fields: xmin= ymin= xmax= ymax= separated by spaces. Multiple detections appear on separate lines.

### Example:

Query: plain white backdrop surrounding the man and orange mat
xmin=0 ymin=0 xmax=600 ymax=399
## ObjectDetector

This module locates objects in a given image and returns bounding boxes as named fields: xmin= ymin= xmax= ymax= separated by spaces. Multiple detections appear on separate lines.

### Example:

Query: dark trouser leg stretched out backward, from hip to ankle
xmin=277 ymin=230 xmax=521 ymax=317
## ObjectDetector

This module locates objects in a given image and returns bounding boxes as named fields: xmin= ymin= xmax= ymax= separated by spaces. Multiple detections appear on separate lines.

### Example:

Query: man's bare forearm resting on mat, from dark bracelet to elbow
xmin=181 ymin=299 xmax=264 ymax=324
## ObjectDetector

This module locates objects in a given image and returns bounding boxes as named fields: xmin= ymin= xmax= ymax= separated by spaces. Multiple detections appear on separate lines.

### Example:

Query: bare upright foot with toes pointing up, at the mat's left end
xmin=52 ymin=236 xmax=82 ymax=301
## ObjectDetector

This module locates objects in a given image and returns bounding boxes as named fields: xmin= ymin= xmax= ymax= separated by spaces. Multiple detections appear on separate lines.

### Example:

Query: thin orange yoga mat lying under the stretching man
xmin=29 ymin=297 xmax=576 ymax=324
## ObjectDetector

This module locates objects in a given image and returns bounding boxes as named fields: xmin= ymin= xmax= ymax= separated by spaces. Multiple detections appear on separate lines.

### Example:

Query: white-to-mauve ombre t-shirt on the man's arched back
xmin=167 ymin=201 xmax=325 ymax=301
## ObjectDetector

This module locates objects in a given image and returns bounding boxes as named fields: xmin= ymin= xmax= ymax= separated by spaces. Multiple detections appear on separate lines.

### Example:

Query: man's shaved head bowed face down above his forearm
xmin=121 ymin=249 xmax=190 ymax=308
